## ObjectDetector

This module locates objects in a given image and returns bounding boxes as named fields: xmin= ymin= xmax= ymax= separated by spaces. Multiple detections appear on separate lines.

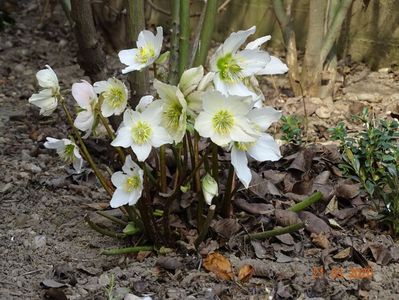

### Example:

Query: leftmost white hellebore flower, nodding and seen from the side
xmin=29 ymin=65 xmax=60 ymax=116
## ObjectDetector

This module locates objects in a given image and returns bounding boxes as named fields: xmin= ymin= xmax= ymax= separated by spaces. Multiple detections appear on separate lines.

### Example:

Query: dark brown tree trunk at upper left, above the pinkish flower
xmin=71 ymin=0 xmax=107 ymax=82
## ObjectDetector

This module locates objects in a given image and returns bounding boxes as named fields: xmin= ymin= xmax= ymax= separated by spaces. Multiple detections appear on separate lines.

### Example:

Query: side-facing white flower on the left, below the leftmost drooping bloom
xmin=44 ymin=137 xmax=83 ymax=173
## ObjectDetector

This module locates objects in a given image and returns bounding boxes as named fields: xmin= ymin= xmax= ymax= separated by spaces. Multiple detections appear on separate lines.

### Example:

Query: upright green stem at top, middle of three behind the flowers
xmin=179 ymin=0 xmax=190 ymax=78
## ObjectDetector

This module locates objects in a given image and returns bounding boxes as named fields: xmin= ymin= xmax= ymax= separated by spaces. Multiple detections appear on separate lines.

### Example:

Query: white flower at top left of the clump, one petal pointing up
xmin=118 ymin=26 xmax=163 ymax=74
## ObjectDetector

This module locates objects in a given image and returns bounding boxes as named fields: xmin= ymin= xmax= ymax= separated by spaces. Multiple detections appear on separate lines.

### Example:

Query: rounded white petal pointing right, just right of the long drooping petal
xmin=248 ymin=133 xmax=281 ymax=161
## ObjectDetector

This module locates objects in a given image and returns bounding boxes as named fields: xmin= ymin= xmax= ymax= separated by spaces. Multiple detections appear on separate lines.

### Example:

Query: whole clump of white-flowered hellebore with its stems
xmin=29 ymin=20 xmax=287 ymax=253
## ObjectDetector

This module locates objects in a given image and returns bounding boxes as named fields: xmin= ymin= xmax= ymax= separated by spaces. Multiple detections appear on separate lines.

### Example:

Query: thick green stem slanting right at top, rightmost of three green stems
xmin=194 ymin=0 xmax=218 ymax=67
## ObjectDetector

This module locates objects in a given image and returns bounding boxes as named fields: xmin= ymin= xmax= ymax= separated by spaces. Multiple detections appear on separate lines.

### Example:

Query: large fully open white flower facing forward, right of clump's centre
xmin=194 ymin=91 xmax=257 ymax=147
